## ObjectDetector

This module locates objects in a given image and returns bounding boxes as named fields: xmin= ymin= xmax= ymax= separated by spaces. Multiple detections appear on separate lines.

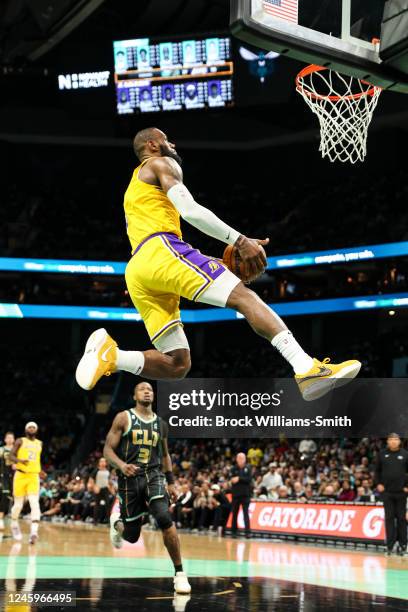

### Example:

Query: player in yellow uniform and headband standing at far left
xmin=10 ymin=421 xmax=42 ymax=544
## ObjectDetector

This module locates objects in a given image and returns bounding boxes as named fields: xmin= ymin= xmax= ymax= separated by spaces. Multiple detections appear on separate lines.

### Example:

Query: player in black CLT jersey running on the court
xmin=103 ymin=382 xmax=191 ymax=593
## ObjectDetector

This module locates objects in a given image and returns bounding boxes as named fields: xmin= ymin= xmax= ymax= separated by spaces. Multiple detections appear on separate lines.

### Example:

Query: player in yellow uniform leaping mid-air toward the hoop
xmin=76 ymin=128 xmax=361 ymax=400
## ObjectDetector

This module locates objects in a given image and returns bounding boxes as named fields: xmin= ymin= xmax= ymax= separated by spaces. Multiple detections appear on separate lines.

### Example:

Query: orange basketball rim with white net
xmin=296 ymin=64 xmax=382 ymax=164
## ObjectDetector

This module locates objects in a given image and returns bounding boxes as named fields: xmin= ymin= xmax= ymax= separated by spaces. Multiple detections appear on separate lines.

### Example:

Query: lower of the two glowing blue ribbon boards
xmin=0 ymin=293 xmax=408 ymax=323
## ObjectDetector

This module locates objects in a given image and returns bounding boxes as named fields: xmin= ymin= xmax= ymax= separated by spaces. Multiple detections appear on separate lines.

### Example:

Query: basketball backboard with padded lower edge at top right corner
xmin=230 ymin=0 xmax=408 ymax=93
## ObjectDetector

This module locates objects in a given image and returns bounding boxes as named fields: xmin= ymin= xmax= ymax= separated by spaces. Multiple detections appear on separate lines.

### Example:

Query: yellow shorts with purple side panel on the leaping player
xmin=125 ymin=233 xmax=239 ymax=343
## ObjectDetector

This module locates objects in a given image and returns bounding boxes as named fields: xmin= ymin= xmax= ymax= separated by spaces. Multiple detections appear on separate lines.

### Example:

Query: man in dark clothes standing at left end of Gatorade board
xmin=230 ymin=453 xmax=252 ymax=538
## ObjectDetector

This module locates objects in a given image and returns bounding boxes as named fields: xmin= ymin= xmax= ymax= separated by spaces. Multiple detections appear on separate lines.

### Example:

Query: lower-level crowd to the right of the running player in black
xmin=166 ymin=437 xmax=381 ymax=530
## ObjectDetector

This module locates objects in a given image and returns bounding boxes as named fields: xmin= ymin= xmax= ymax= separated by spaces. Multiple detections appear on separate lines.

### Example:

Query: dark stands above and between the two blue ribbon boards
xmin=0 ymin=142 xmax=408 ymax=316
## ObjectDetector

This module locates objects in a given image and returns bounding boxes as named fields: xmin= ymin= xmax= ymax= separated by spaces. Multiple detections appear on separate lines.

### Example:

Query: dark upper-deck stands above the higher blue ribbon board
xmin=0 ymin=148 xmax=408 ymax=261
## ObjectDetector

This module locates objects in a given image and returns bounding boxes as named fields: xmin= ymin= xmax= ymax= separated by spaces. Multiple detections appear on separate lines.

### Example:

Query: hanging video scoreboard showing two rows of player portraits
xmin=113 ymin=37 xmax=233 ymax=115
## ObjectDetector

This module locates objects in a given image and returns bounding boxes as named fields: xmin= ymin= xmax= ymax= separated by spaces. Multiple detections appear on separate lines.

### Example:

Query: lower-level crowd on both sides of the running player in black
xmin=25 ymin=436 xmax=396 ymax=534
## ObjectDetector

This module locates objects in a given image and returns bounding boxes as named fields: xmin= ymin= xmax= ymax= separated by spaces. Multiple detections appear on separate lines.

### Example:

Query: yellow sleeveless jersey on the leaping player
xmin=123 ymin=159 xmax=181 ymax=252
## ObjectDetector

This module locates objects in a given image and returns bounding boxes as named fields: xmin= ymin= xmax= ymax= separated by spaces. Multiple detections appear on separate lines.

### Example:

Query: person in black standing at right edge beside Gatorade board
xmin=375 ymin=433 xmax=408 ymax=555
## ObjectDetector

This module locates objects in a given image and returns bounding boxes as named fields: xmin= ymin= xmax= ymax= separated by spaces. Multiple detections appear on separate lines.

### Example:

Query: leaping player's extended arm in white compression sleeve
xmin=150 ymin=157 xmax=269 ymax=272
